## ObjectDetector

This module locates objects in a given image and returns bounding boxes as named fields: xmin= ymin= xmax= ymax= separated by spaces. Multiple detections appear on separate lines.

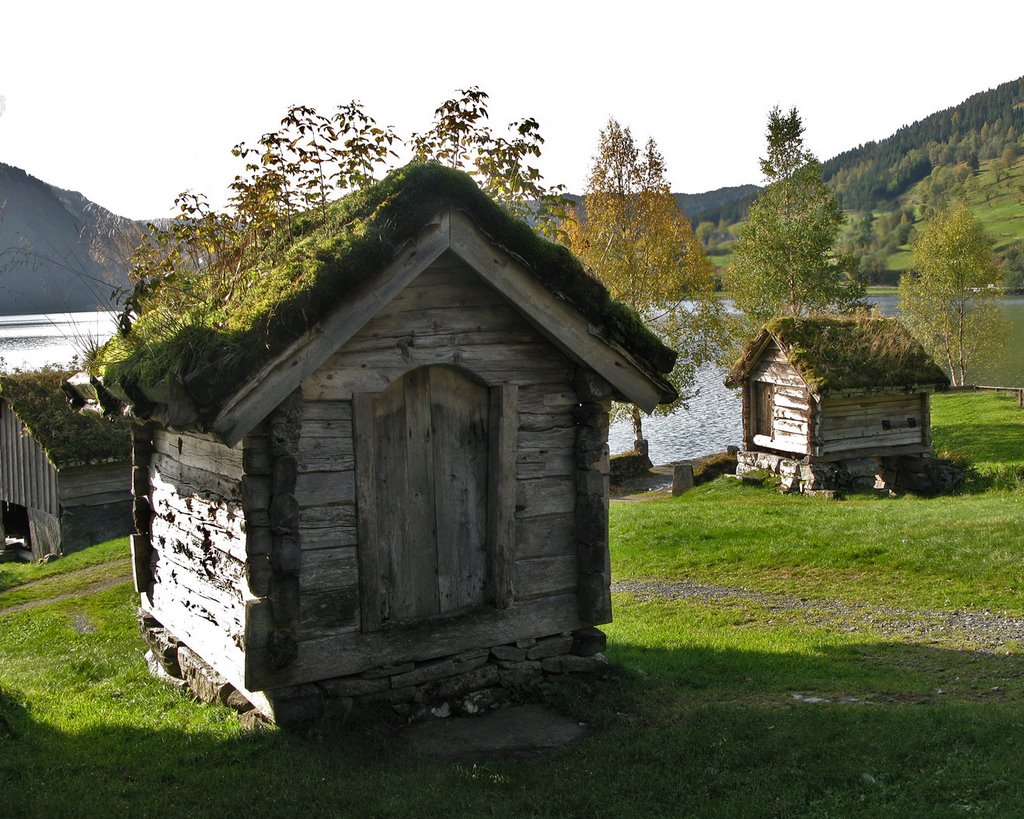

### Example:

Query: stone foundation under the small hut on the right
xmin=736 ymin=450 xmax=964 ymax=495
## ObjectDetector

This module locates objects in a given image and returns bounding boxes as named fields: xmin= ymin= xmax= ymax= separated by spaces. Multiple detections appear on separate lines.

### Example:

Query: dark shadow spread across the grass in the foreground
xmin=0 ymin=642 xmax=1024 ymax=817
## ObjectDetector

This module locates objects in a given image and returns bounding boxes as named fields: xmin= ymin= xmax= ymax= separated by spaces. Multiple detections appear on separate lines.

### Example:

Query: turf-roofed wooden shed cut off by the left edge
xmin=0 ymin=369 xmax=131 ymax=559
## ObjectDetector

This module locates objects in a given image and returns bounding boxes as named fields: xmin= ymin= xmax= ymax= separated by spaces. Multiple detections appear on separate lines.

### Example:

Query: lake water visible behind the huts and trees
xmin=0 ymin=296 xmax=1024 ymax=464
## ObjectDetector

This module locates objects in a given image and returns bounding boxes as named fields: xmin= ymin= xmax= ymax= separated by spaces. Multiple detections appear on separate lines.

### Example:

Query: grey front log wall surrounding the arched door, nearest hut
xmin=242 ymin=256 xmax=589 ymax=687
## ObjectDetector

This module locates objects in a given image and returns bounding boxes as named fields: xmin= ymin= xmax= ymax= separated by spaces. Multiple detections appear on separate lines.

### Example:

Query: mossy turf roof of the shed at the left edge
xmin=0 ymin=368 xmax=131 ymax=469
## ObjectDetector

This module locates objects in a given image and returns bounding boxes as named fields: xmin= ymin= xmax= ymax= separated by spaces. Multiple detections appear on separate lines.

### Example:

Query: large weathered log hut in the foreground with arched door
xmin=106 ymin=165 xmax=675 ymax=725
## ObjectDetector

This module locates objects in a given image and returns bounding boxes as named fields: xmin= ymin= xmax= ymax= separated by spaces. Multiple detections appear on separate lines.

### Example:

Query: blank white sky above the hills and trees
xmin=0 ymin=0 xmax=1024 ymax=218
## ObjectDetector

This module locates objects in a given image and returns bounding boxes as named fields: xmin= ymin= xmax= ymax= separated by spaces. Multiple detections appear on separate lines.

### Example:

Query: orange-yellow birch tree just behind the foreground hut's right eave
xmin=562 ymin=119 xmax=722 ymax=446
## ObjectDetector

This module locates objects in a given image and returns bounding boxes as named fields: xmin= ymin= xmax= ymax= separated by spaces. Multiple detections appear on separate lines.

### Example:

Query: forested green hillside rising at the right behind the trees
xmin=691 ymin=78 xmax=1024 ymax=289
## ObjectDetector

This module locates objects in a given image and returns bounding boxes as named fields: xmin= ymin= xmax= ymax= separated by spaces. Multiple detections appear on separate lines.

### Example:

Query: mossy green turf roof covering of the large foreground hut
xmin=100 ymin=163 xmax=676 ymax=417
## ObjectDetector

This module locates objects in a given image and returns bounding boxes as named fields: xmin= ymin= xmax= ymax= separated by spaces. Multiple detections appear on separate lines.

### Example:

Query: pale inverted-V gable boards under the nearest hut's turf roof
xmin=212 ymin=210 xmax=663 ymax=446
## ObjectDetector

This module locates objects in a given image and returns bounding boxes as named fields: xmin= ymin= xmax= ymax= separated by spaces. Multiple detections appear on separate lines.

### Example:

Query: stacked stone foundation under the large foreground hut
xmin=139 ymin=612 xmax=606 ymax=729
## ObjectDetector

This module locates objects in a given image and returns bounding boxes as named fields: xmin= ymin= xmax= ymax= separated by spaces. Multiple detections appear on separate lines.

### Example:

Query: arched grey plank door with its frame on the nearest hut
xmin=353 ymin=367 xmax=508 ymax=630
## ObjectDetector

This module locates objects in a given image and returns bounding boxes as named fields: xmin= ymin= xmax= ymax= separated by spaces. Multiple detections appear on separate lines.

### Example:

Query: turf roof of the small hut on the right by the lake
xmin=725 ymin=316 xmax=949 ymax=395
